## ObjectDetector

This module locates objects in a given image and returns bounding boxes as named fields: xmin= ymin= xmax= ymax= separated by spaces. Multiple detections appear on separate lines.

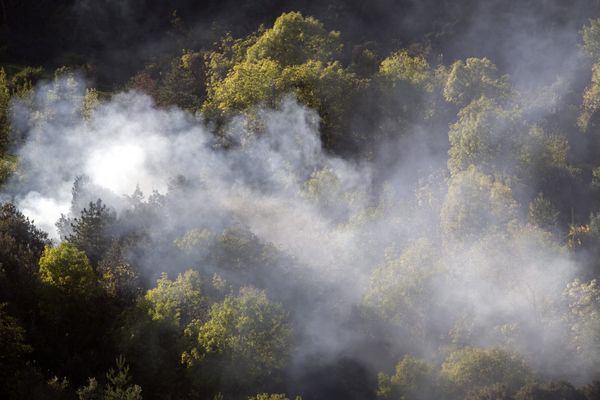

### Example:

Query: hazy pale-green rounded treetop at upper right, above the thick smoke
xmin=444 ymin=58 xmax=511 ymax=107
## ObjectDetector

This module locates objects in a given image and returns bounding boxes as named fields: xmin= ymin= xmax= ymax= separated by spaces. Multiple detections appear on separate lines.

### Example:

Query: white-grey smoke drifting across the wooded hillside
xmin=2 ymin=2 xmax=594 ymax=390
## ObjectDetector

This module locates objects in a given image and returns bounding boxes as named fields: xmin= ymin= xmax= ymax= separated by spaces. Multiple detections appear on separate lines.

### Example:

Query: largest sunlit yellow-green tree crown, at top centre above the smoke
xmin=202 ymin=12 xmax=365 ymax=153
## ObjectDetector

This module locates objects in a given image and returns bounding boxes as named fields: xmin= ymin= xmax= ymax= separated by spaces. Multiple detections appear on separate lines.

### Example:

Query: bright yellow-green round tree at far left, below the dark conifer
xmin=40 ymin=242 xmax=96 ymax=297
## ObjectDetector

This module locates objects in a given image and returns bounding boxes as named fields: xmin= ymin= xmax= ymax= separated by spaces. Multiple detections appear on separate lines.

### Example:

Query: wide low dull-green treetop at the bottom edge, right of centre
xmin=440 ymin=347 xmax=531 ymax=393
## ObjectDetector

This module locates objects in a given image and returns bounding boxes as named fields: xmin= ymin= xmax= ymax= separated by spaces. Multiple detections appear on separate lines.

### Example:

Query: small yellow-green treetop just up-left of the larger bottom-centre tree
xmin=145 ymin=270 xmax=206 ymax=327
